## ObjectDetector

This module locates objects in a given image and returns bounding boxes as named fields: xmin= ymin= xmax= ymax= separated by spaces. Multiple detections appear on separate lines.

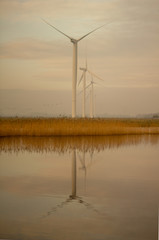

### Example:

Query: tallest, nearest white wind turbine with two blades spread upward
xmin=42 ymin=19 xmax=106 ymax=118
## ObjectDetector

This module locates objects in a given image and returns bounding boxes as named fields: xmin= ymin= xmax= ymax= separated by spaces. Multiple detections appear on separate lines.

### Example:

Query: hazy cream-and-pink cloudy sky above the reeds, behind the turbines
xmin=0 ymin=0 xmax=159 ymax=116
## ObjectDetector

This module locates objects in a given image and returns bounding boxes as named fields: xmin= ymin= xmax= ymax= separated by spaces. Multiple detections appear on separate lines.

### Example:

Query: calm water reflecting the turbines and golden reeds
xmin=0 ymin=136 xmax=159 ymax=240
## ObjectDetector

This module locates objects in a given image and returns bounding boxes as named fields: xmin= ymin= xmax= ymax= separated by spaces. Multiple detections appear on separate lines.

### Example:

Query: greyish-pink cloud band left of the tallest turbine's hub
xmin=0 ymin=38 xmax=71 ymax=60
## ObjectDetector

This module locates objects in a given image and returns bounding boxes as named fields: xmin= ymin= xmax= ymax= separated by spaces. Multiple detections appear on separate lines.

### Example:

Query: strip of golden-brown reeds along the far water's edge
xmin=0 ymin=118 xmax=159 ymax=137
